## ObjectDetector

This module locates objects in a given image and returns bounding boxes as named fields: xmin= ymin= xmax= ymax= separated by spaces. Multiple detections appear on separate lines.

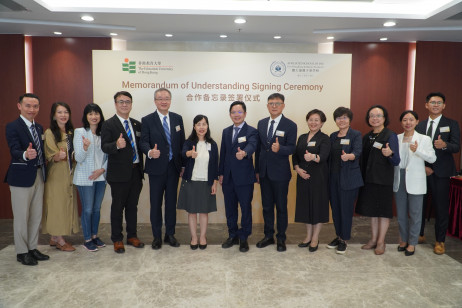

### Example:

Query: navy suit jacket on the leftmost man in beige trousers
xmin=4 ymin=117 xmax=46 ymax=187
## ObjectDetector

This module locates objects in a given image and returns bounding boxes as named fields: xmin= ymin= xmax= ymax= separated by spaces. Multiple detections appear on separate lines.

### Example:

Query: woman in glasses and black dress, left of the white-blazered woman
xmin=356 ymin=105 xmax=400 ymax=255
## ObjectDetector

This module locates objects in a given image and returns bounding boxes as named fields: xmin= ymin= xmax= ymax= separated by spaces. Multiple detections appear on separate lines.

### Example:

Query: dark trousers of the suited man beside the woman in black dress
xmin=260 ymin=177 xmax=289 ymax=241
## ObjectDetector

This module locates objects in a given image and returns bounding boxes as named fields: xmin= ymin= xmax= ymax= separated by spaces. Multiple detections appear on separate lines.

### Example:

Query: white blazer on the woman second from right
xmin=393 ymin=131 xmax=436 ymax=195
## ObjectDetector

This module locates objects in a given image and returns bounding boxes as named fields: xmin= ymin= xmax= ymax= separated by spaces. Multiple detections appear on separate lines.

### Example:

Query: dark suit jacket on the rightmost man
xmin=415 ymin=116 xmax=460 ymax=177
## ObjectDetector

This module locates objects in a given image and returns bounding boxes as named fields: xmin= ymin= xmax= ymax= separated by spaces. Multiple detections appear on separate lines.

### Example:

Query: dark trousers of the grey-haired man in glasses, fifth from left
xmin=149 ymin=160 xmax=179 ymax=238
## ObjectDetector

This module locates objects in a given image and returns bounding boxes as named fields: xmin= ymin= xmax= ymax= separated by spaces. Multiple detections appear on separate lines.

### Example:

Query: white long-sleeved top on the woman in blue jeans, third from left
xmin=73 ymin=127 xmax=107 ymax=186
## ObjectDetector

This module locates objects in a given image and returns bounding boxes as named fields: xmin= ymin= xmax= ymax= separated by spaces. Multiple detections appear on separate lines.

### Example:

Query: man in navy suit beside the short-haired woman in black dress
xmin=255 ymin=93 xmax=297 ymax=251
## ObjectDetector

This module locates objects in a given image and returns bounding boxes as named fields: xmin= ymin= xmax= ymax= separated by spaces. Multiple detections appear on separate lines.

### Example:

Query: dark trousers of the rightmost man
xmin=420 ymin=173 xmax=451 ymax=242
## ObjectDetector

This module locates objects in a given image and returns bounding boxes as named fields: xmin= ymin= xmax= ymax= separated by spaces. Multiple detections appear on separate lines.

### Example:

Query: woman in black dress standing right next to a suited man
xmin=292 ymin=109 xmax=330 ymax=252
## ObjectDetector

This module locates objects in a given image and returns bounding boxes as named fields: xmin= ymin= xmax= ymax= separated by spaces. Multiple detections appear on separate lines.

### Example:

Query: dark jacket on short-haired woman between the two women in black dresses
xmin=330 ymin=128 xmax=364 ymax=190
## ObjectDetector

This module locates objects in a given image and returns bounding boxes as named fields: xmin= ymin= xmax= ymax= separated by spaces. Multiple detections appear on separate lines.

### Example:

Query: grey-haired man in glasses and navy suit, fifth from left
xmin=141 ymin=88 xmax=185 ymax=250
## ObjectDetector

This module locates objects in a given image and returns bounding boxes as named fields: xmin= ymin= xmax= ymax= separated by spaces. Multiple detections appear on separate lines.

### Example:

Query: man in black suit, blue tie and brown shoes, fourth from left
xmin=101 ymin=91 xmax=144 ymax=253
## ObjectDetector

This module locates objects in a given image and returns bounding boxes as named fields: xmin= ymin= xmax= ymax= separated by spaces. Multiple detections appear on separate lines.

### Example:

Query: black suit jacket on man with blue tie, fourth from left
xmin=101 ymin=115 xmax=143 ymax=182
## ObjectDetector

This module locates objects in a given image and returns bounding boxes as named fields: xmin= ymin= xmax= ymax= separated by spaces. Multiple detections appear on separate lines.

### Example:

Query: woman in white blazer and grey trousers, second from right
xmin=393 ymin=110 xmax=436 ymax=256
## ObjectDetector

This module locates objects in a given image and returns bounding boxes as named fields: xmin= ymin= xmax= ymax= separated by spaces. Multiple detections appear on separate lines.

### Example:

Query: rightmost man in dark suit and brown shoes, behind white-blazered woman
xmin=416 ymin=92 xmax=460 ymax=255
